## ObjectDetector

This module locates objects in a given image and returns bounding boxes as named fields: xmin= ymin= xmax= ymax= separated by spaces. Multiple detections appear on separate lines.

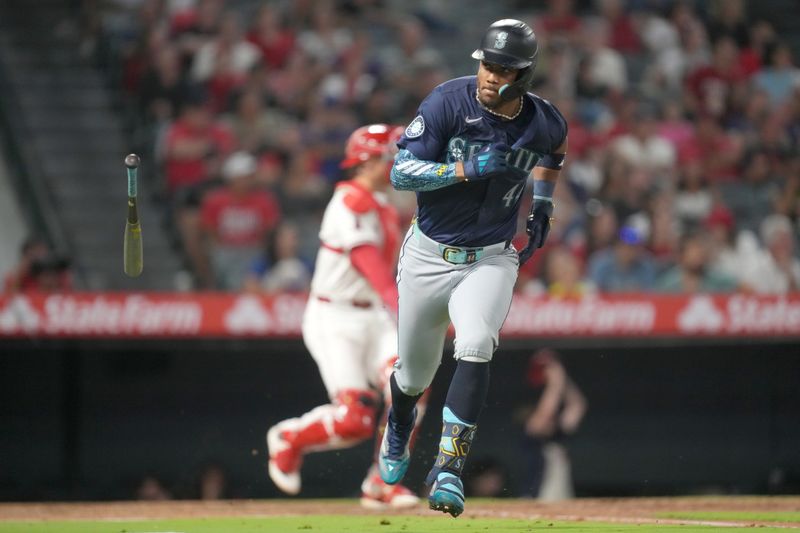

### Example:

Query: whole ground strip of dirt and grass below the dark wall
xmin=0 ymin=497 xmax=800 ymax=533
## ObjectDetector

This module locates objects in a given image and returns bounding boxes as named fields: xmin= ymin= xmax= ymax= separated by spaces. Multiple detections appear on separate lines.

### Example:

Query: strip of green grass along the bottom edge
xmin=0 ymin=513 xmax=797 ymax=533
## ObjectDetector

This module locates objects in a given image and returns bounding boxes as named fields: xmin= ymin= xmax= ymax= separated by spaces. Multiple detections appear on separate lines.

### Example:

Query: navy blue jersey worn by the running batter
xmin=397 ymin=76 xmax=567 ymax=246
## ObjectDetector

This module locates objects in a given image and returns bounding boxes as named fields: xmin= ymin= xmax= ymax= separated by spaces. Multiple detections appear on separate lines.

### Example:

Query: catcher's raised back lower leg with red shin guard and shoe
xmin=267 ymin=389 xmax=378 ymax=494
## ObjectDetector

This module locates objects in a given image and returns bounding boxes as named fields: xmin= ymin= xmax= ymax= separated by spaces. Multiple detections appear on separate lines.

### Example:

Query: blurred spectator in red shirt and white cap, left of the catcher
xmin=201 ymin=152 xmax=280 ymax=290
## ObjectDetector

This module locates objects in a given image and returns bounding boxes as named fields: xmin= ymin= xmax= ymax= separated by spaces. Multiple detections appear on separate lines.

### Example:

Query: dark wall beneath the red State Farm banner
xmin=0 ymin=341 xmax=800 ymax=500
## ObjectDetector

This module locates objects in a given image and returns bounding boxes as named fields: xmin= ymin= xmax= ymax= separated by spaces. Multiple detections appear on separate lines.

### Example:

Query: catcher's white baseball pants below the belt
xmin=303 ymin=296 xmax=397 ymax=400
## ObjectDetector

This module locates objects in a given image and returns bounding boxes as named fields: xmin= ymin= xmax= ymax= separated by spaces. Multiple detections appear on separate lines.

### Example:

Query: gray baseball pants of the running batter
xmin=395 ymin=224 xmax=519 ymax=396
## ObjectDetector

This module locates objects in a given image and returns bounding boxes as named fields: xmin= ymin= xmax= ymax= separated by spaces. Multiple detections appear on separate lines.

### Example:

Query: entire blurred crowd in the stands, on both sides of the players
xmin=12 ymin=0 xmax=800 ymax=297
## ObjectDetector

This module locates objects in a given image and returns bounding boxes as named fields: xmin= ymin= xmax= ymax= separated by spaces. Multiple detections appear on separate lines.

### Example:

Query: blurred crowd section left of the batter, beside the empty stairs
xmin=94 ymin=0 xmax=449 ymax=292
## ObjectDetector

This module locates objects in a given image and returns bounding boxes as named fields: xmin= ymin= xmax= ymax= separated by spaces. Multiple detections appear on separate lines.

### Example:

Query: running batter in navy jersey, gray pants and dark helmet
xmin=378 ymin=19 xmax=567 ymax=516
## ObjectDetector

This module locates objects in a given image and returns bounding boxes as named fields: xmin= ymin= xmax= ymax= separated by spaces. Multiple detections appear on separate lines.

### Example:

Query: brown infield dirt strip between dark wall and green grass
xmin=0 ymin=496 xmax=800 ymax=529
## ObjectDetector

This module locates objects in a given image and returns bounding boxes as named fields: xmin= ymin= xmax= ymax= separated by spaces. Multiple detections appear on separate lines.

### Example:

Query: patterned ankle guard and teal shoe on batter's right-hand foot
xmin=425 ymin=407 xmax=478 ymax=517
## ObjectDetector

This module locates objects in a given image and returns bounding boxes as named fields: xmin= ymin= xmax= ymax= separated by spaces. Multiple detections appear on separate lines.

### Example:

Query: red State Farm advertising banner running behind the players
xmin=0 ymin=293 xmax=800 ymax=339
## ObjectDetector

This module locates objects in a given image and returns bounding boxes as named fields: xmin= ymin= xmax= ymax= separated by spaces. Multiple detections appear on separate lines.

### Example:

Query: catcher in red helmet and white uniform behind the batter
xmin=267 ymin=124 xmax=422 ymax=508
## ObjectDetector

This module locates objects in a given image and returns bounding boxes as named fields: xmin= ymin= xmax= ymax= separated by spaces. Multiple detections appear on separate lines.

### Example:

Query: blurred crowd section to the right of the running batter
xmin=521 ymin=0 xmax=800 ymax=296
